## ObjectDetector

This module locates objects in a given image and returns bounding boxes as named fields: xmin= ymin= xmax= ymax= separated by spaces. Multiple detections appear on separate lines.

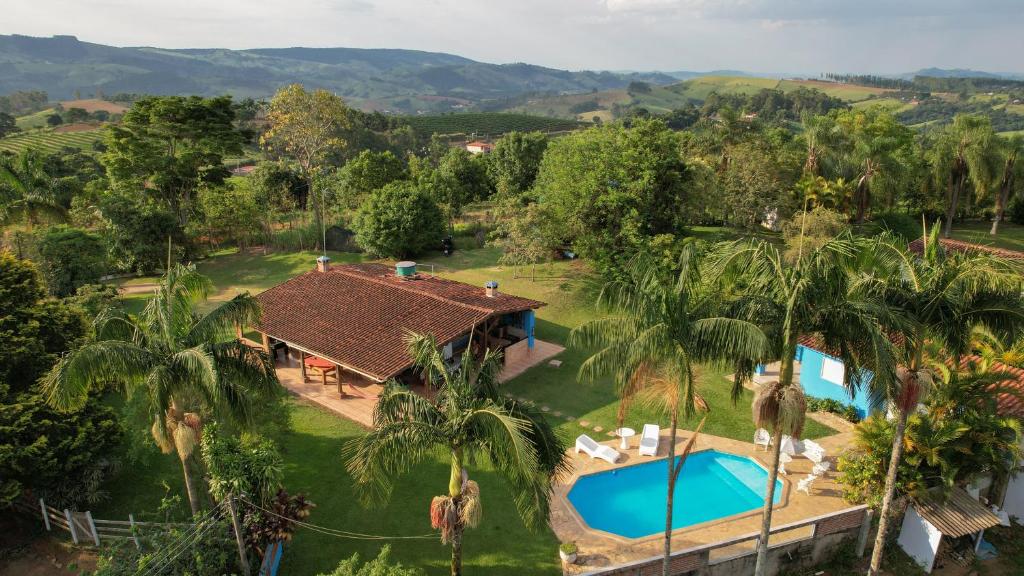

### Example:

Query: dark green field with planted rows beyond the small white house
xmin=406 ymin=112 xmax=580 ymax=137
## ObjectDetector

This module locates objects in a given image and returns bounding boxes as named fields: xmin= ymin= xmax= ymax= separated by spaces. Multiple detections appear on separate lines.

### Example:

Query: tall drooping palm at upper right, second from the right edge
xmin=932 ymin=115 xmax=993 ymax=238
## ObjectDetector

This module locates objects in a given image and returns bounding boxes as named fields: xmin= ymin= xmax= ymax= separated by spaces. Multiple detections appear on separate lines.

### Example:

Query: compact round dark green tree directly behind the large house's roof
xmin=352 ymin=181 xmax=444 ymax=258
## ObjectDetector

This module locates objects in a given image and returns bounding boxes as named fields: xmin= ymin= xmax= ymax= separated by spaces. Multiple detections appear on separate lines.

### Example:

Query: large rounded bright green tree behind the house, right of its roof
xmin=532 ymin=120 xmax=688 ymax=271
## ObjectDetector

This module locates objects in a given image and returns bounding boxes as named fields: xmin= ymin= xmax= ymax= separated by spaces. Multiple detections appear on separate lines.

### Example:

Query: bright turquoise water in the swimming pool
xmin=568 ymin=450 xmax=782 ymax=538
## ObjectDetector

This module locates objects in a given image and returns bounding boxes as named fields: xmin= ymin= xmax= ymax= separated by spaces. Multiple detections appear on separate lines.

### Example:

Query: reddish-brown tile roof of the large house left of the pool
xmin=256 ymin=263 xmax=544 ymax=380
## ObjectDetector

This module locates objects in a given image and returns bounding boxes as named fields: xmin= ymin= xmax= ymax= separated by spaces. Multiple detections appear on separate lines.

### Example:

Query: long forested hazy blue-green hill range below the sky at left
xmin=0 ymin=35 xmax=674 ymax=112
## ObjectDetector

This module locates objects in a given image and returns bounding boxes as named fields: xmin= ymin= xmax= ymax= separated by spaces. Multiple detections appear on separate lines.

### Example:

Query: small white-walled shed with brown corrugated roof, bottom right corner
xmin=899 ymin=488 xmax=999 ymax=574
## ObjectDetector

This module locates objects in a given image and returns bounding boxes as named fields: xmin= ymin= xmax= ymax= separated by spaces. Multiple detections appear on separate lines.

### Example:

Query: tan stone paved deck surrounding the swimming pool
xmin=551 ymin=426 xmax=852 ymax=574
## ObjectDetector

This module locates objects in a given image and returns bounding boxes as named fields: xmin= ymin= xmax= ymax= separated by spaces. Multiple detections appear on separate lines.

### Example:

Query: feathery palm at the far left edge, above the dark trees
xmin=0 ymin=149 xmax=68 ymax=231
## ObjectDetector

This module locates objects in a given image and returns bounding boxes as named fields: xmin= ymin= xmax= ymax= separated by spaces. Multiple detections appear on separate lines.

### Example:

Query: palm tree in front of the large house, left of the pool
xmin=344 ymin=334 xmax=566 ymax=576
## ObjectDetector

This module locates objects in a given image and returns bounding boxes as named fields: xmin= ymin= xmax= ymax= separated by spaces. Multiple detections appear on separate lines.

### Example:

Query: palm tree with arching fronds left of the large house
xmin=42 ymin=264 xmax=281 ymax=513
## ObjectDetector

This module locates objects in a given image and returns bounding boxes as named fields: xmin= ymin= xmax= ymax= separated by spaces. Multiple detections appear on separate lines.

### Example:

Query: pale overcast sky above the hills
xmin=0 ymin=0 xmax=1024 ymax=73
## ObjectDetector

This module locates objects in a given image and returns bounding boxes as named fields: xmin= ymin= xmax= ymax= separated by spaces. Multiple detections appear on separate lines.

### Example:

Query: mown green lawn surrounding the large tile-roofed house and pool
xmin=96 ymin=242 xmax=831 ymax=576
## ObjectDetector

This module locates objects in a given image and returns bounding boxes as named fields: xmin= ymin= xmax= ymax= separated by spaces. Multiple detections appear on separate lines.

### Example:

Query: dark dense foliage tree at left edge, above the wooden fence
xmin=0 ymin=252 xmax=123 ymax=506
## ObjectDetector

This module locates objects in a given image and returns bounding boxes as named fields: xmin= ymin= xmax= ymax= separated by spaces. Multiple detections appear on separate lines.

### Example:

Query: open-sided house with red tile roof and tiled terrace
xmin=252 ymin=256 xmax=562 ymax=424
